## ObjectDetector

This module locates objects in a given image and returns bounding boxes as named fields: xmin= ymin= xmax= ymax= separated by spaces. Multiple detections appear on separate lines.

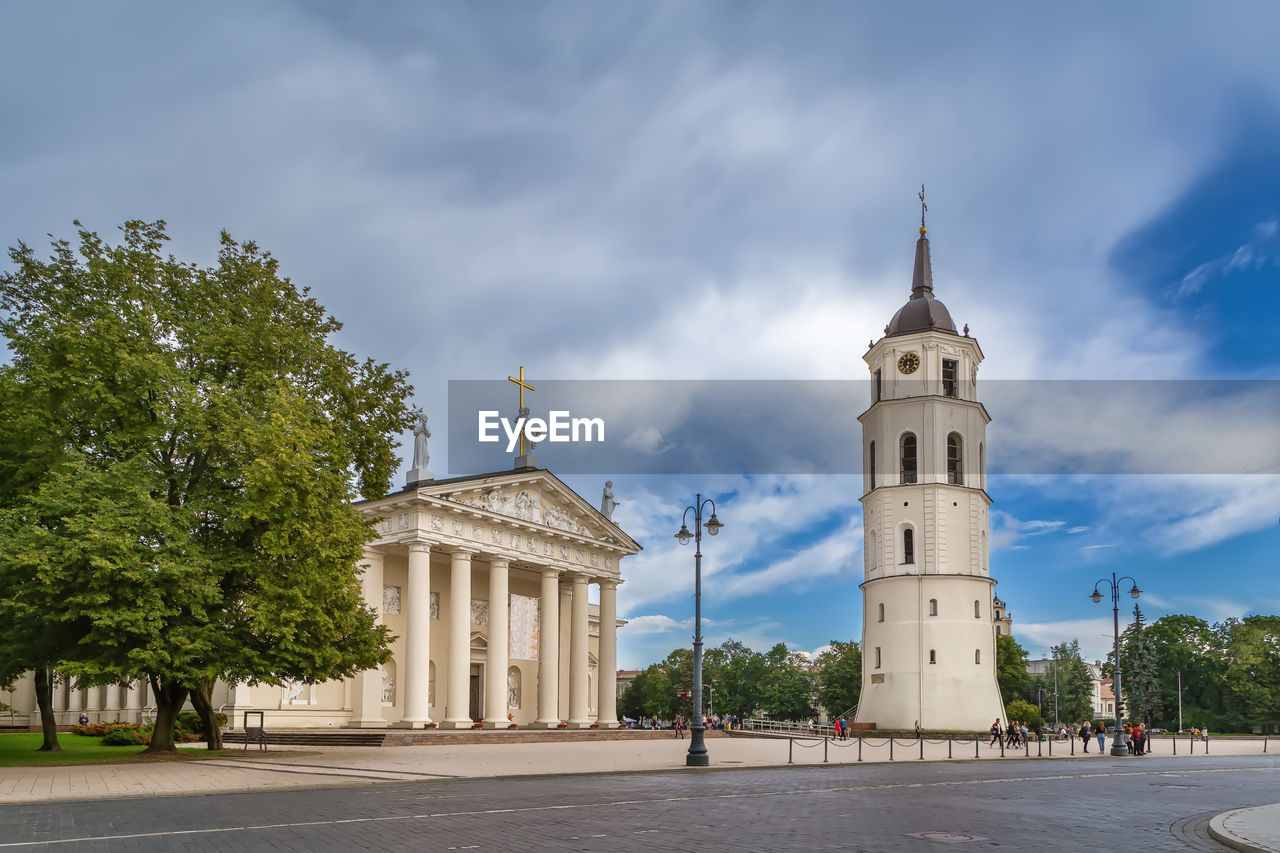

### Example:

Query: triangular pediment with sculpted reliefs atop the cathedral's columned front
xmin=362 ymin=469 xmax=640 ymax=553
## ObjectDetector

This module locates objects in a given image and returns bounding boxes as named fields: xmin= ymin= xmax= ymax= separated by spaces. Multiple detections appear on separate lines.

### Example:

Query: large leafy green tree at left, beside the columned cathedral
xmin=0 ymin=222 xmax=412 ymax=752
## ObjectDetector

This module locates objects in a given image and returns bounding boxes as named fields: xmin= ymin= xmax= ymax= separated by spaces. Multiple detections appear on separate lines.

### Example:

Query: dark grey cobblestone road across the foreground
xmin=0 ymin=756 xmax=1280 ymax=853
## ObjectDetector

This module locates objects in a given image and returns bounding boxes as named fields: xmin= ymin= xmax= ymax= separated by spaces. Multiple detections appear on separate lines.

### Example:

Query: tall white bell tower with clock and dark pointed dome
xmin=856 ymin=187 xmax=1005 ymax=731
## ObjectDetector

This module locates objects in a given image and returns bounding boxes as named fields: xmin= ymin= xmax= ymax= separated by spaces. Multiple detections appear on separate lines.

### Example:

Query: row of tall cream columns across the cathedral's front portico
xmin=352 ymin=542 xmax=618 ymax=729
